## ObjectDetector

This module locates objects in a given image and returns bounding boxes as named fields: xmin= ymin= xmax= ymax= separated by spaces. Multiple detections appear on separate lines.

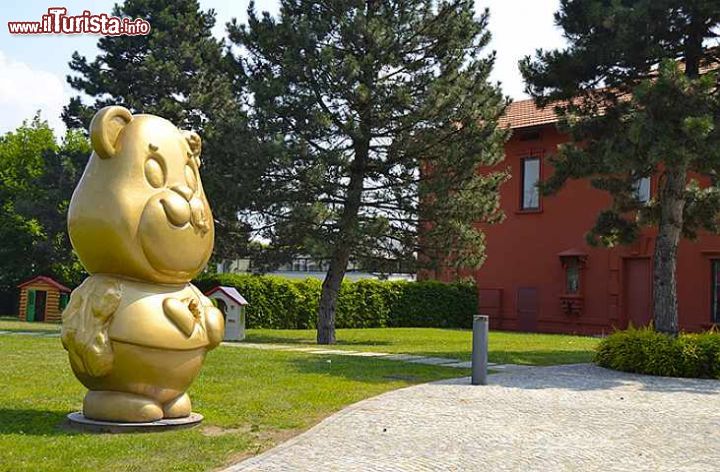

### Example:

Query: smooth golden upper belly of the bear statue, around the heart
xmin=108 ymin=280 xmax=208 ymax=351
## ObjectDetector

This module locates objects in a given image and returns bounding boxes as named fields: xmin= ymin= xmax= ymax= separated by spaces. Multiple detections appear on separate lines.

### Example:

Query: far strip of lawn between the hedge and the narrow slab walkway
xmin=246 ymin=328 xmax=599 ymax=365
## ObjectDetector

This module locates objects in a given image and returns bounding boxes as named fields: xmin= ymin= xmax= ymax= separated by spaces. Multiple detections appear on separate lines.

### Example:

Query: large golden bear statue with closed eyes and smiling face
xmin=62 ymin=106 xmax=224 ymax=422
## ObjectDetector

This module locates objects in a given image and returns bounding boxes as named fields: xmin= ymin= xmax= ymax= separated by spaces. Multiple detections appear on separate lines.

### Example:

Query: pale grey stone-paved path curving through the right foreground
xmin=227 ymin=364 xmax=720 ymax=472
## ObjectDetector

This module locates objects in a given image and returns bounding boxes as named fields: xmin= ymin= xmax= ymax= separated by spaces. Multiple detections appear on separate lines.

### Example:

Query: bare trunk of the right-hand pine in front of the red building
xmin=653 ymin=167 xmax=687 ymax=335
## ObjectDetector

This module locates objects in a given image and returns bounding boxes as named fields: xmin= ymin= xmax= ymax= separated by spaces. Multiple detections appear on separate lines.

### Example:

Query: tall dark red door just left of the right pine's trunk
xmin=623 ymin=258 xmax=652 ymax=326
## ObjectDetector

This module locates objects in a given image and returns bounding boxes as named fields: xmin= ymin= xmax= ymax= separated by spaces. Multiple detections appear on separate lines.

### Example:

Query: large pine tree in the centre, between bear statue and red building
xmin=229 ymin=0 xmax=508 ymax=344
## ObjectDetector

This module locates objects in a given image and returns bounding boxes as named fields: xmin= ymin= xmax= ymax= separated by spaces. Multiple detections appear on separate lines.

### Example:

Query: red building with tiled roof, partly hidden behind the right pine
xmin=443 ymin=100 xmax=720 ymax=334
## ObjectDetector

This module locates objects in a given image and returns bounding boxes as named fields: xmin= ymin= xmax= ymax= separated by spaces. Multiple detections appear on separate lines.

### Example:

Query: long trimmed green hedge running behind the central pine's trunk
xmin=194 ymin=274 xmax=477 ymax=329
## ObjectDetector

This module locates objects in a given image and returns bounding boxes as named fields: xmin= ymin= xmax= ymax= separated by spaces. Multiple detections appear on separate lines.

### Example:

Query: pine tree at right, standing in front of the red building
xmin=520 ymin=0 xmax=720 ymax=334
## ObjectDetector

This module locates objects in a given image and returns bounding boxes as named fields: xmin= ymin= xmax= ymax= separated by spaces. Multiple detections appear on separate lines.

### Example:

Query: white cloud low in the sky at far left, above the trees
xmin=0 ymin=51 xmax=70 ymax=136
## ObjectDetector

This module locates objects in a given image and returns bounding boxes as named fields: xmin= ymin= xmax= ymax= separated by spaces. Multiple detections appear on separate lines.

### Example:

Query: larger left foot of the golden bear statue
xmin=83 ymin=390 xmax=163 ymax=423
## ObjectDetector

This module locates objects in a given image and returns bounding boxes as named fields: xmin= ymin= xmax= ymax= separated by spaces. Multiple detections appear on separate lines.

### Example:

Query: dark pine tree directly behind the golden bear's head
xmin=63 ymin=0 xmax=261 ymax=258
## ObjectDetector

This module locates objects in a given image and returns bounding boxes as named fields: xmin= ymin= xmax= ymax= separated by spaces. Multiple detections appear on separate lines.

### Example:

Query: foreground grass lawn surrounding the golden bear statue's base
xmin=0 ymin=330 xmax=469 ymax=471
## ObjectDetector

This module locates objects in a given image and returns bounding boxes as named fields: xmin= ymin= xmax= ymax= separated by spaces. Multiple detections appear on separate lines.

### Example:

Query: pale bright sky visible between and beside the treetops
xmin=0 ymin=0 xmax=565 ymax=134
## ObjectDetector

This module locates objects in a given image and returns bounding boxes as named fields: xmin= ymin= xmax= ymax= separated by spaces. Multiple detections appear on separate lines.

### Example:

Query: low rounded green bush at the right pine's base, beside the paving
xmin=595 ymin=328 xmax=720 ymax=379
